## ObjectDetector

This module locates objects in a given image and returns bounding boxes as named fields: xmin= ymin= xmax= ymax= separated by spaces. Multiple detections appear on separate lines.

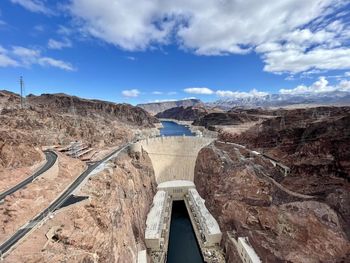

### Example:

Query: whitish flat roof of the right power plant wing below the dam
xmin=188 ymin=189 xmax=221 ymax=235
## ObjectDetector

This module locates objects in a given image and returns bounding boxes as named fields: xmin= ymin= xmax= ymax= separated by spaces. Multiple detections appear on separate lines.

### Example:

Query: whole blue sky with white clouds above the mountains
xmin=0 ymin=0 xmax=350 ymax=104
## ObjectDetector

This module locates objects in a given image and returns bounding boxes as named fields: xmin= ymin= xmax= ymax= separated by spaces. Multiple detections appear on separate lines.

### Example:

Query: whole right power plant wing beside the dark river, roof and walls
xmin=185 ymin=188 xmax=222 ymax=247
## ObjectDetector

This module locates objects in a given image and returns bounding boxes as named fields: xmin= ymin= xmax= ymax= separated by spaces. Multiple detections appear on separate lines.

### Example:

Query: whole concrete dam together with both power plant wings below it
xmin=137 ymin=136 xmax=224 ymax=263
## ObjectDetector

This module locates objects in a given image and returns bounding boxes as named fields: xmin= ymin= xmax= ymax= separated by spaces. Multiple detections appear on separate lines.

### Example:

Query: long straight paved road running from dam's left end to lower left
xmin=0 ymin=144 xmax=130 ymax=256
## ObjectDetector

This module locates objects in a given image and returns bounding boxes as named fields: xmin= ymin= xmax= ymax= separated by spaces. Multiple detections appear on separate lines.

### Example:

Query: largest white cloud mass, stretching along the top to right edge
xmin=68 ymin=0 xmax=350 ymax=73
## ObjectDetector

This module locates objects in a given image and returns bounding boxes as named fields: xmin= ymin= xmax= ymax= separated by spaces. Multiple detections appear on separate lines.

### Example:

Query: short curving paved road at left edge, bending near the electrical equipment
xmin=0 ymin=151 xmax=57 ymax=200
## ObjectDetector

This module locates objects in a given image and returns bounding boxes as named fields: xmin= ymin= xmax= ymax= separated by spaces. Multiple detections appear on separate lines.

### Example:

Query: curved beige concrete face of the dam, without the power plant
xmin=134 ymin=136 xmax=213 ymax=184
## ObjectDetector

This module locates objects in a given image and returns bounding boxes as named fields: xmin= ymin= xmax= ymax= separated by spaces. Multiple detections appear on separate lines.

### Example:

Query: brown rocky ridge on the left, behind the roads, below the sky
xmin=0 ymin=91 xmax=157 ymax=169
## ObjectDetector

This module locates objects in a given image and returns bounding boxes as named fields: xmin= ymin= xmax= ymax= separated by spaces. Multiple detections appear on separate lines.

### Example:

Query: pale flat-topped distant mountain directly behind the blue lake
xmin=137 ymin=99 xmax=202 ymax=115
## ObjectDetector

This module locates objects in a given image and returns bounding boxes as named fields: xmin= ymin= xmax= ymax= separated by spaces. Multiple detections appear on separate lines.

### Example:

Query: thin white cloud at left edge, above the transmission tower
xmin=0 ymin=46 xmax=76 ymax=71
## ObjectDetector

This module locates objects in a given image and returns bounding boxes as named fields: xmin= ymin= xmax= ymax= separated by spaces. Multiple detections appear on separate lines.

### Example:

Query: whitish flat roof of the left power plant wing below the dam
xmin=145 ymin=191 xmax=167 ymax=239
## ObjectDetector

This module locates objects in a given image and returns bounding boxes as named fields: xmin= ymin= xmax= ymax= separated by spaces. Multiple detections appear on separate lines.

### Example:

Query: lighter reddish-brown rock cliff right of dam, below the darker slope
xmin=195 ymin=143 xmax=350 ymax=263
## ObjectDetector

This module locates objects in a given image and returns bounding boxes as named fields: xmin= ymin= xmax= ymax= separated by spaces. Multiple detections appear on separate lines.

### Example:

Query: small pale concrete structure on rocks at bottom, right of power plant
xmin=227 ymin=232 xmax=261 ymax=263
